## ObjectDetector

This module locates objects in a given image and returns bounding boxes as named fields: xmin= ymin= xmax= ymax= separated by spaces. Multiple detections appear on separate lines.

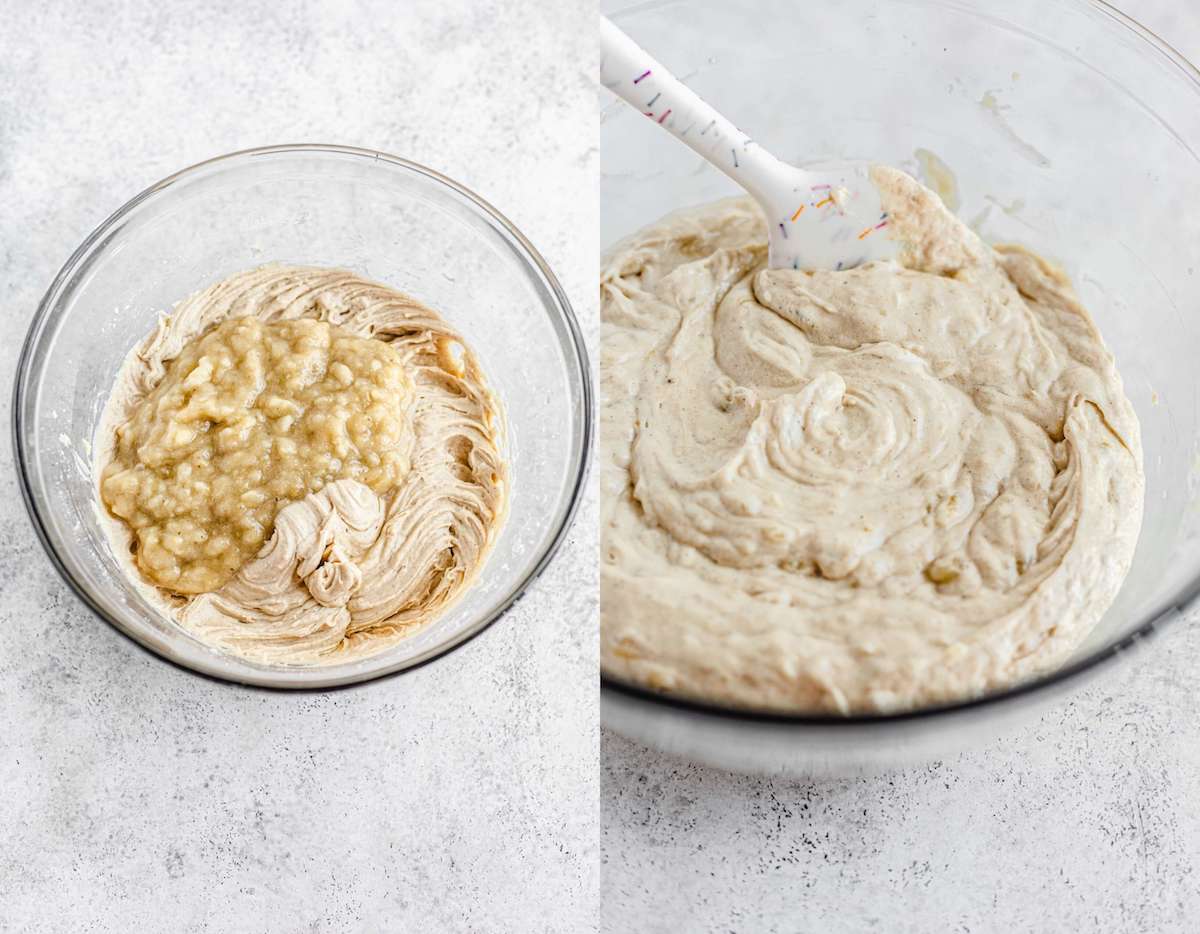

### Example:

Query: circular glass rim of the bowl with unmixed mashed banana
xmin=11 ymin=143 xmax=595 ymax=693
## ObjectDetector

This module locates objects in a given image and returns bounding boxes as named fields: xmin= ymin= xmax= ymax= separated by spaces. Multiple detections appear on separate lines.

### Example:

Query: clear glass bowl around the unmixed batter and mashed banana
xmin=13 ymin=145 xmax=592 ymax=688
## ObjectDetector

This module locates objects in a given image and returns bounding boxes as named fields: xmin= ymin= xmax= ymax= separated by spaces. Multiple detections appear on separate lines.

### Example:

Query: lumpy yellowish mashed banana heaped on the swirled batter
xmin=101 ymin=317 xmax=413 ymax=593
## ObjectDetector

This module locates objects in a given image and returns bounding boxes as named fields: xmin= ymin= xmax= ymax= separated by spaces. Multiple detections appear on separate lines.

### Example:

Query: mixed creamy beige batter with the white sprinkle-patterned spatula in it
xmin=601 ymin=168 xmax=1144 ymax=714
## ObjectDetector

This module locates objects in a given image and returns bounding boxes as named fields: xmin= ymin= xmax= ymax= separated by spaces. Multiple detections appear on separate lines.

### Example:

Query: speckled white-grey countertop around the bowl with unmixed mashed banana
xmin=0 ymin=0 xmax=598 ymax=932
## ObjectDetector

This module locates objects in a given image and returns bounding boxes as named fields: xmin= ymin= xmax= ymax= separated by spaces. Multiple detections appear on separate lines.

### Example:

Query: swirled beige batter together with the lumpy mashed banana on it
xmin=96 ymin=265 xmax=508 ymax=665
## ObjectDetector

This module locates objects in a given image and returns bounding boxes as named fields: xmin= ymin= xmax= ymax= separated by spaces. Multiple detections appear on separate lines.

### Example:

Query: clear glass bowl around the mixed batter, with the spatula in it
xmin=600 ymin=0 xmax=1200 ymax=774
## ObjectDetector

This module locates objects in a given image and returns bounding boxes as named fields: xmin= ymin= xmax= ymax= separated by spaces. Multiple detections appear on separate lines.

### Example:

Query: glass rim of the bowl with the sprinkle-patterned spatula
xmin=600 ymin=0 xmax=1200 ymax=732
